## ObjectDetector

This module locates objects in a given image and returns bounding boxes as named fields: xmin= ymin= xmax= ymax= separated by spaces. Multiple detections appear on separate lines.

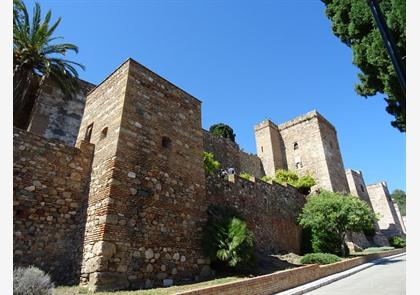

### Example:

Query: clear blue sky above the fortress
xmin=33 ymin=0 xmax=405 ymax=191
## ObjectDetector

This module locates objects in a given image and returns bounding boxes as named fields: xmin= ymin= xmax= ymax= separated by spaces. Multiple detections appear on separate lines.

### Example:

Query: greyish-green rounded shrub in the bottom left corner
xmin=13 ymin=266 xmax=54 ymax=295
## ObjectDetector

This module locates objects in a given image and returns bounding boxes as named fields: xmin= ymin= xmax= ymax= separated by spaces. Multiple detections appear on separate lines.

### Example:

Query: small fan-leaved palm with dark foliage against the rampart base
xmin=202 ymin=205 xmax=254 ymax=268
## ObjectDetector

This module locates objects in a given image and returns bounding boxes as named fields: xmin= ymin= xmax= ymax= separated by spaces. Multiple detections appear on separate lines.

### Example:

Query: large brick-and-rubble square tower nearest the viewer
xmin=77 ymin=59 xmax=208 ymax=290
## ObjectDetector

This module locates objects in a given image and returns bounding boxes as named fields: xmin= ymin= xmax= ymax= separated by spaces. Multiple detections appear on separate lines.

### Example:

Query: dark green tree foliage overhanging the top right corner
xmin=322 ymin=0 xmax=406 ymax=132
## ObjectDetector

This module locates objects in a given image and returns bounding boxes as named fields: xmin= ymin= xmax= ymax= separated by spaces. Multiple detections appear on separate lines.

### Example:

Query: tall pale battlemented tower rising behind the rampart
xmin=255 ymin=111 xmax=349 ymax=192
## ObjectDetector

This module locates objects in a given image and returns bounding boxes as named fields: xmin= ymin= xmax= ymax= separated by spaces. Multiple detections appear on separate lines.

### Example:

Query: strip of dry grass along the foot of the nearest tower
xmin=53 ymin=276 xmax=247 ymax=295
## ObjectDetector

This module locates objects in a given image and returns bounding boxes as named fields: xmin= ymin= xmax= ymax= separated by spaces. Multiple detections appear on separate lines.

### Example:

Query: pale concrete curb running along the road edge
xmin=275 ymin=252 xmax=406 ymax=295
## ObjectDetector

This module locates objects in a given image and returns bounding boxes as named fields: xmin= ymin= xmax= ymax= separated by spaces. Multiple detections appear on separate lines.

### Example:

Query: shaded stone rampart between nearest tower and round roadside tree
xmin=206 ymin=175 xmax=305 ymax=253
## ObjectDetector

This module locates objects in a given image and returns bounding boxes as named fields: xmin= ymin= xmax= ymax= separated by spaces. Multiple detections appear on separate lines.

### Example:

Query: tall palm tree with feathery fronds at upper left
xmin=13 ymin=0 xmax=84 ymax=129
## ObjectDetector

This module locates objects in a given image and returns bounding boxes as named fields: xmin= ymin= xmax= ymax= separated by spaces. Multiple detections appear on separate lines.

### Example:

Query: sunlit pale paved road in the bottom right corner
xmin=305 ymin=255 xmax=406 ymax=295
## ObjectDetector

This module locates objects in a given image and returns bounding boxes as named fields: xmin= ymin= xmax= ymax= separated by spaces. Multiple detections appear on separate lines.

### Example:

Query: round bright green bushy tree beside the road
xmin=299 ymin=191 xmax=376 ymax=256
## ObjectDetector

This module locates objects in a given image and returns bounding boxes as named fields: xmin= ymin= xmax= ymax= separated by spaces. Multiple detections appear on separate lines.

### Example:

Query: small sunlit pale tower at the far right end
xmin=367 ymin=181 xmax=404 ymax=237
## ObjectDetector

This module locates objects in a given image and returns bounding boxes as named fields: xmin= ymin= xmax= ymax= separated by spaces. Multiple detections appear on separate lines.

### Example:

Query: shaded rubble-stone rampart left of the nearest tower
xmin=13 ymin=128 xmax=94 ymax=284
